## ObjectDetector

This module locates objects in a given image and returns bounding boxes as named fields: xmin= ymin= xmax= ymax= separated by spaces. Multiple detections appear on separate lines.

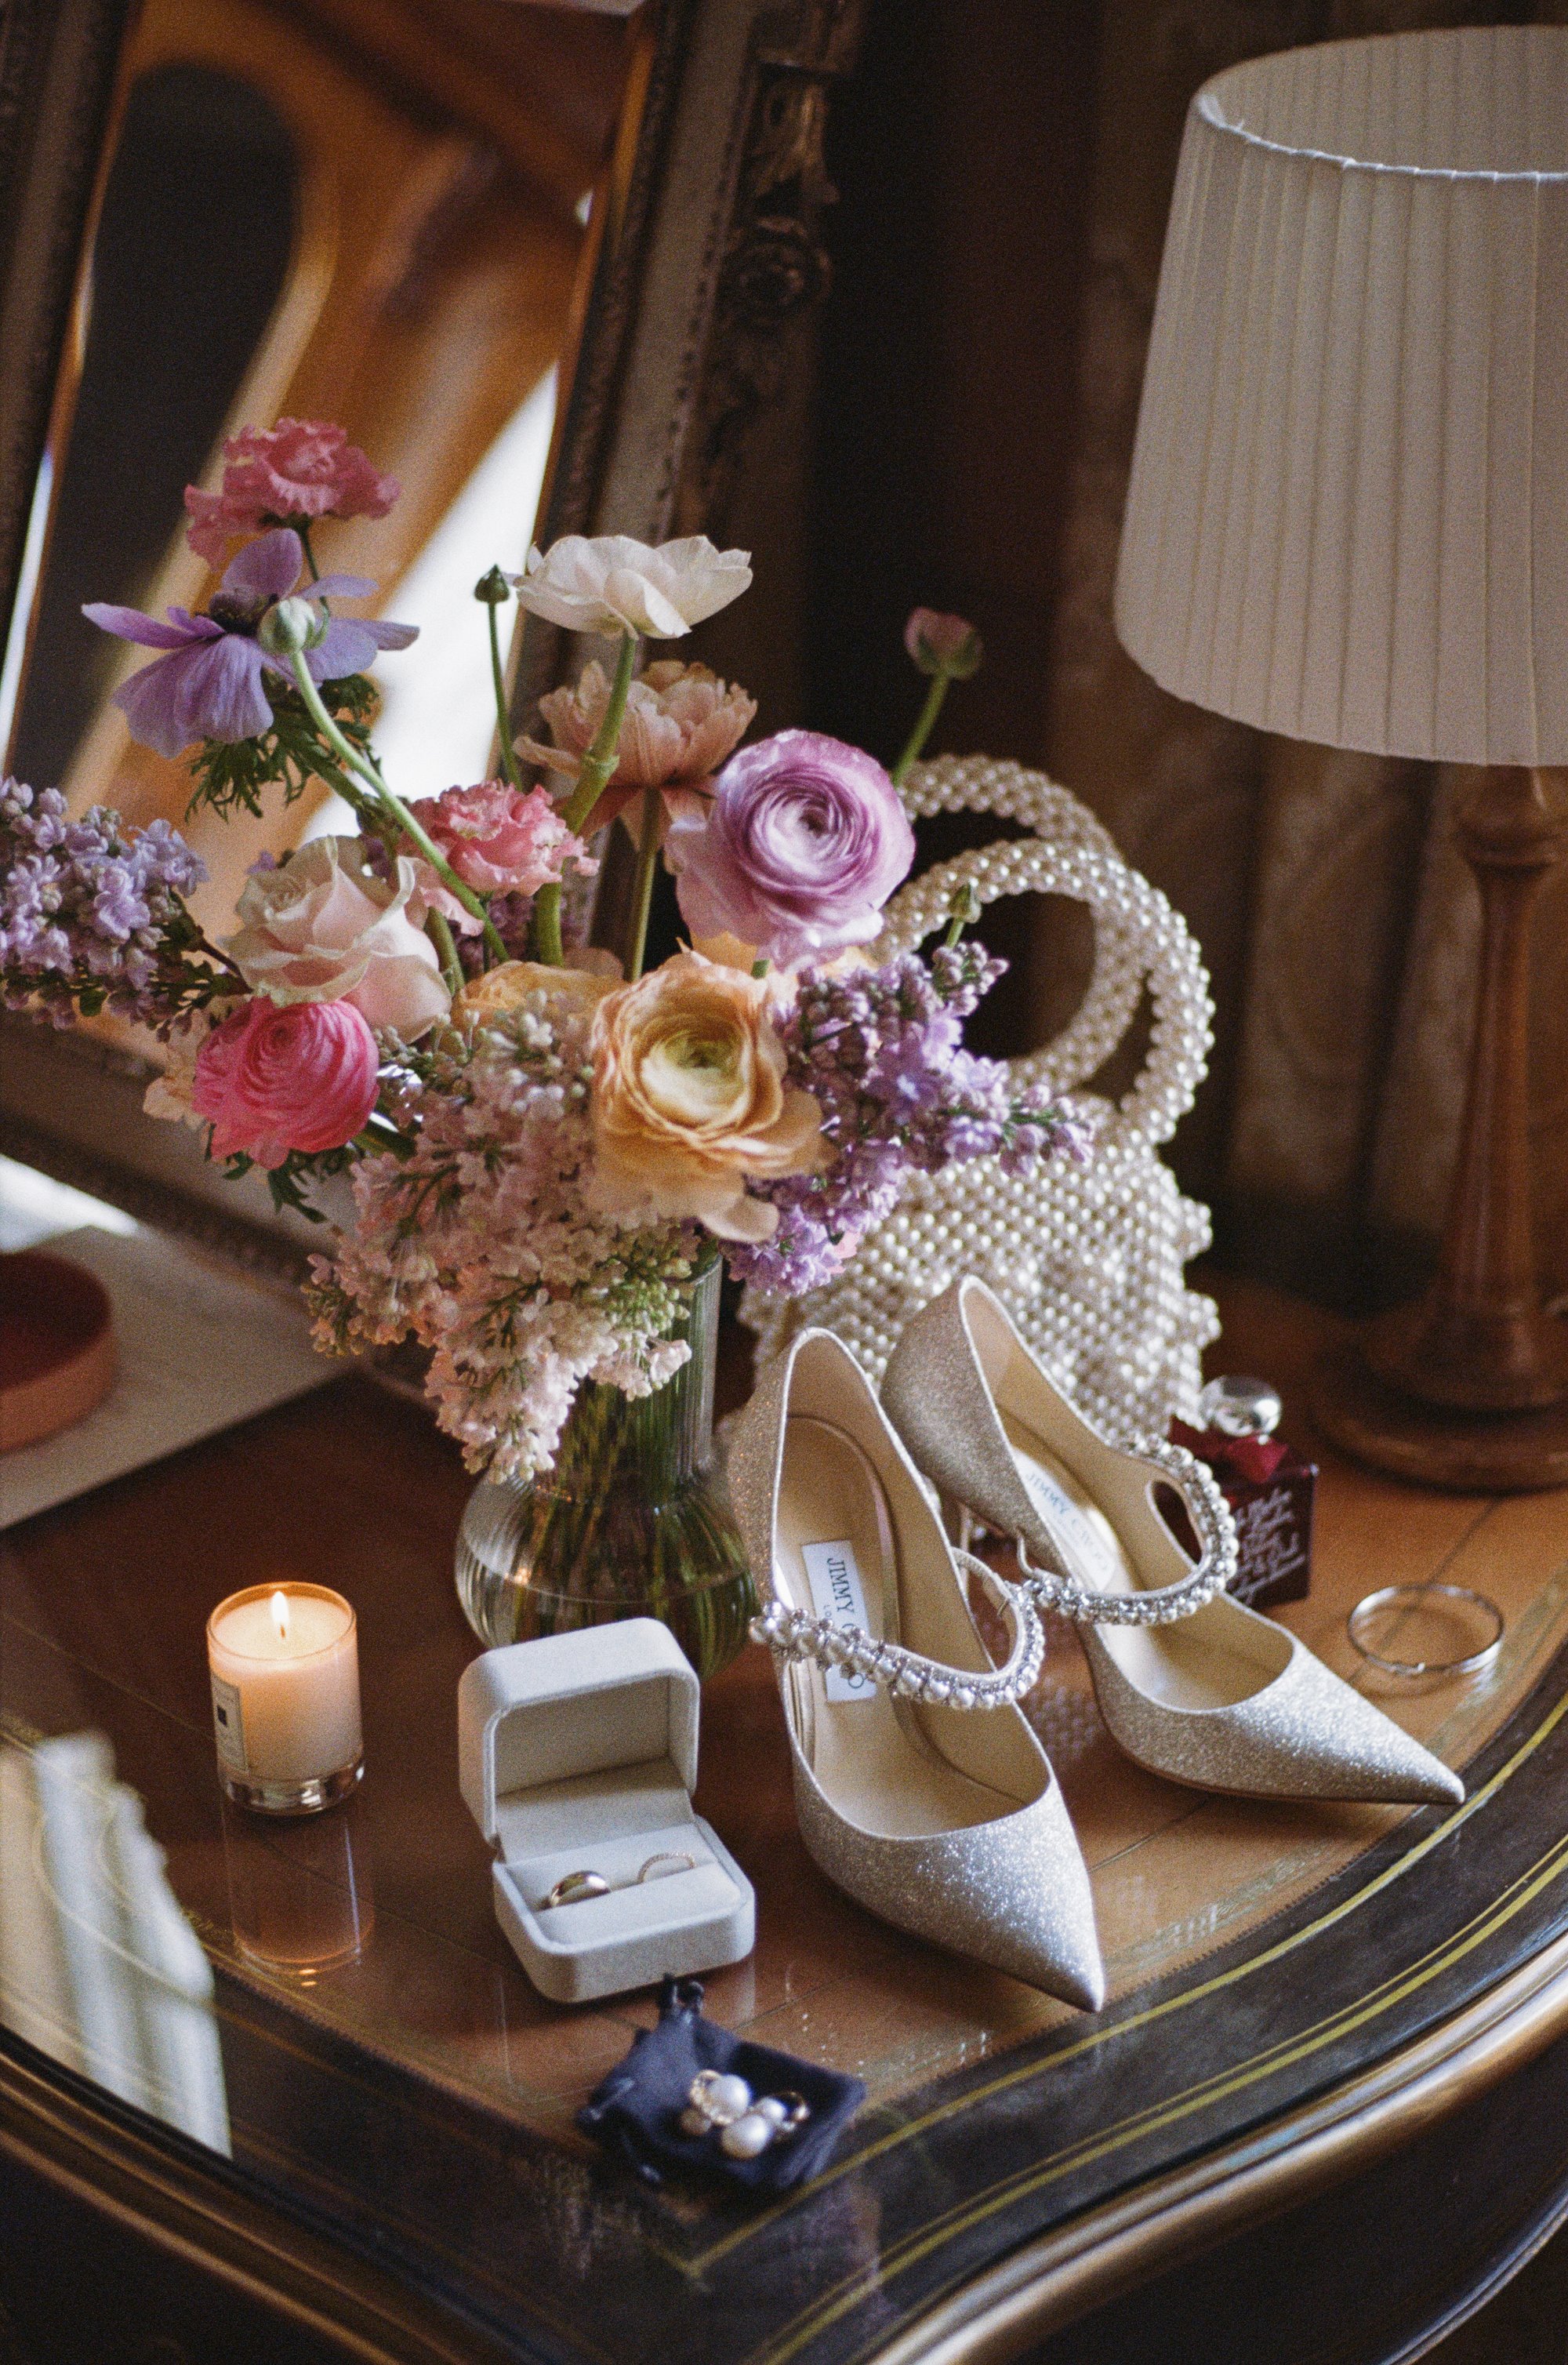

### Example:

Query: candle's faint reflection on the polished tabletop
xmin=223 ymin=1800 xmax=376 ymax=1986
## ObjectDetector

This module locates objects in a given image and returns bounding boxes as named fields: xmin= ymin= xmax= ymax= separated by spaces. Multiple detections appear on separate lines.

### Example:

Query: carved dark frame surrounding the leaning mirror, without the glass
xmin=0 ymin=0 xmax=866 ymax=1268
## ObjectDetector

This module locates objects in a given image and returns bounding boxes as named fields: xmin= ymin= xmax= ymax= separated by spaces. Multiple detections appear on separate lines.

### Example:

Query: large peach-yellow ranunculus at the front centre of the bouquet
xmin=586 ymin=953 xmax=826 ymax=1241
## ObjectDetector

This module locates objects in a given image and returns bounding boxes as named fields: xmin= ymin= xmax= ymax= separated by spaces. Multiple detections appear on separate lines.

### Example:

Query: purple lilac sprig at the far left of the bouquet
xmin=0 ymin=778 xmax=230 ymax=1029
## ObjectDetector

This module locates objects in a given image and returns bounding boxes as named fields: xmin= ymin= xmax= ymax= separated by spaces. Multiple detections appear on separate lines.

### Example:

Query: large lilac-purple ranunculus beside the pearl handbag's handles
xmin=665 ymin=731 xmax=915 ymax=970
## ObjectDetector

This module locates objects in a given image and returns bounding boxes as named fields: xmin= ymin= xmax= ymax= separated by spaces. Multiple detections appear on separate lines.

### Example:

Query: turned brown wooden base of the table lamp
xmin=1312 ymin=766 xmax=1568 ymax=1492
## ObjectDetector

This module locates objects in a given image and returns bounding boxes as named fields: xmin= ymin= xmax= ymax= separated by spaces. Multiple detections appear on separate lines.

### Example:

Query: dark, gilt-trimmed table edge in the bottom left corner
xmin=0 ymin=2032 xmax=527 ymax=2365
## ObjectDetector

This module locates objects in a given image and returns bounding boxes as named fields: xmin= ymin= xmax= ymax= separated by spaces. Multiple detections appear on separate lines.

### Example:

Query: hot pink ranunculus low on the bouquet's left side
xmin=191 ymin=994 xmax=379 ymax=1166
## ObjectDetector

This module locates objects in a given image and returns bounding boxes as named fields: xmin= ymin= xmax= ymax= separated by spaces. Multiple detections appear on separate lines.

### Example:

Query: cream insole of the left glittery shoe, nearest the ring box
xmin=773 ymin=1415 xmax=1019 ymax=1840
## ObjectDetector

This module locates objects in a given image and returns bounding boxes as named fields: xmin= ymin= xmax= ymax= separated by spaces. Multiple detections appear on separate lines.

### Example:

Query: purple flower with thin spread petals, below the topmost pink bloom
xmin=83 ymin=525 xmax=419 ymax=757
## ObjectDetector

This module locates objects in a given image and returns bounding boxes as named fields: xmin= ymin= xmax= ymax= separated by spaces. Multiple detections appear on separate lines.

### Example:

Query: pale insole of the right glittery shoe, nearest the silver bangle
xmin=1003 ymin=1412 xmax=1289 ymax=1710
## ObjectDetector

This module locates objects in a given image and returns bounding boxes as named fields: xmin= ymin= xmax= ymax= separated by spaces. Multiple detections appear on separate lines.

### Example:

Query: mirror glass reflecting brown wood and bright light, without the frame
xmin=12 ymin=0 xmax=631 ymax=950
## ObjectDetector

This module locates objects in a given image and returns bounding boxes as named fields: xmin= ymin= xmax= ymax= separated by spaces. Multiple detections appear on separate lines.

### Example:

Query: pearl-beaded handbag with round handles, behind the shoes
xmin=740 ymin=757 xmax=1221 ymax=1440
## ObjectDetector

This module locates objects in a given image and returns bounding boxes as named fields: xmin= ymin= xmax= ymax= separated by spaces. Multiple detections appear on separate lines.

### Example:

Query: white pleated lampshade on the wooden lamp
xmin=1116 ymin=26 xmax=1568 ymax=764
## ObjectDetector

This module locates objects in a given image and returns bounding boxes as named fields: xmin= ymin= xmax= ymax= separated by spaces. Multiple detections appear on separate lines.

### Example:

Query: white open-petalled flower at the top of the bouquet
xmin=509 ymin=535 xmax=752 ymax=641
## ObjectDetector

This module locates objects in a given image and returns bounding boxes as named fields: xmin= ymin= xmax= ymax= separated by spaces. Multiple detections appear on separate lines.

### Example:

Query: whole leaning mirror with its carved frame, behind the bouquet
xmin=0 ymin=0 xmax=863 ymax=1270
